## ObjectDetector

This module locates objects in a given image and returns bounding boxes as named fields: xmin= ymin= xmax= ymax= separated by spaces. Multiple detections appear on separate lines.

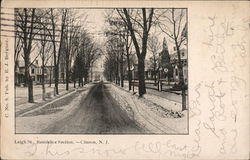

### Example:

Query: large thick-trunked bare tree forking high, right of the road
xmin=117 ymin=8 xmax=154 ymax=97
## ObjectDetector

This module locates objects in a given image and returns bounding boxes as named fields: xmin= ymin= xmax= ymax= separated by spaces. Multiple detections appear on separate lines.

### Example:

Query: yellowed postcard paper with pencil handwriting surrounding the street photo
xmin=1 ymin=1 xmax=250 ymax=159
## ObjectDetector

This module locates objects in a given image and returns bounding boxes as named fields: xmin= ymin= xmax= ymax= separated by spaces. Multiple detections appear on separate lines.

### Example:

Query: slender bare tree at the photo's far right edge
xmin=158 ymin=8 xmax=187 ymax=110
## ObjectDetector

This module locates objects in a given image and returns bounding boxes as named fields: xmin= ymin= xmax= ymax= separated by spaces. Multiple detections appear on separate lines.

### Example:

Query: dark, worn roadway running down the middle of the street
xmin=42 ymin=82 xmax=143 ymax=134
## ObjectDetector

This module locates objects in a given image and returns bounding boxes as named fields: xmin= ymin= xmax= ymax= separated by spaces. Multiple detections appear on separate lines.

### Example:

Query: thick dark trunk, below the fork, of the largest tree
xmin=138 ymin=57 xmax=146 ymax=97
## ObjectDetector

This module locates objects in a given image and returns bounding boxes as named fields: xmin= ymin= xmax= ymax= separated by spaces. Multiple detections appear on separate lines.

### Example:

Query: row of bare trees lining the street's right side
xmin=104 ymin=8 xmax=187 ymax=110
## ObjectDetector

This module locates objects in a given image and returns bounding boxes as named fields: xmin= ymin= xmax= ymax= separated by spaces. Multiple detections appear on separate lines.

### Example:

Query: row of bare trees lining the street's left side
xmin=14 ymin=8 xmax=102 ymax=103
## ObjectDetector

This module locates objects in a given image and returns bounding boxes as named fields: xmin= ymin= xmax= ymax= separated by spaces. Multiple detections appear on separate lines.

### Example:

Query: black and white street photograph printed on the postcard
xmin=12 ymin=8 xmax=189 ymax=135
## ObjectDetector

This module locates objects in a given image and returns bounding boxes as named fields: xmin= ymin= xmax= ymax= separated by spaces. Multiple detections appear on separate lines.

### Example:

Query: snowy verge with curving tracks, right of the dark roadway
xmin=109 ymin=84 xmax=188 ymax=134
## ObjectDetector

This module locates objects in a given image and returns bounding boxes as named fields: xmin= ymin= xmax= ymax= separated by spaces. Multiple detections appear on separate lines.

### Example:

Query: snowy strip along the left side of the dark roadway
xmin=16 ymin=84 xmax=93 ymax=133
